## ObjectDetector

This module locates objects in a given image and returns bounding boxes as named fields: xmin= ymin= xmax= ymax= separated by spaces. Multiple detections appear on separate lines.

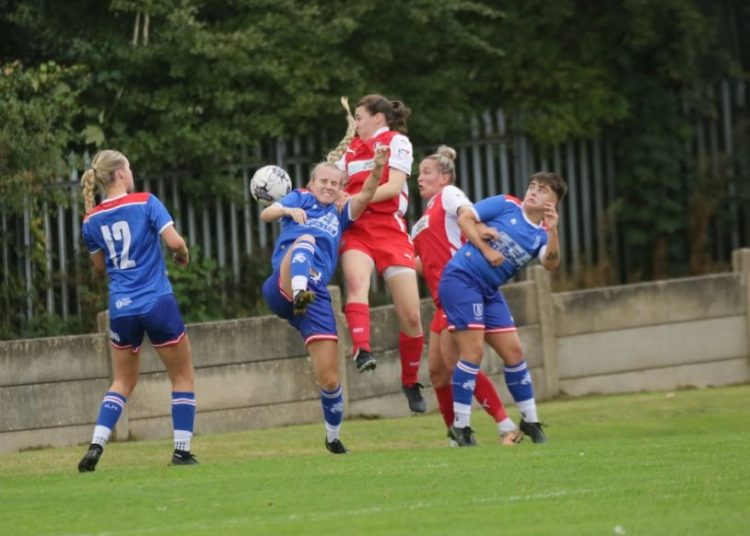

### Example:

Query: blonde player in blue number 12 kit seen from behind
xmin=78 ymin=150 xmax=198 ymax=472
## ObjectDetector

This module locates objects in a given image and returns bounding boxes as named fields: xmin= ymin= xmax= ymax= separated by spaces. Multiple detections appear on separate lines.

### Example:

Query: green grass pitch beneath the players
xmin=0 ymin=385 xmax=750 ymax=535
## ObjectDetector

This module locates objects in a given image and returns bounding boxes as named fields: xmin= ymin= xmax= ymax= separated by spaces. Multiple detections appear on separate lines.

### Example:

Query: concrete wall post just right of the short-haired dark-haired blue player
xmin=529 ymin=266 xmax=560 ymax=398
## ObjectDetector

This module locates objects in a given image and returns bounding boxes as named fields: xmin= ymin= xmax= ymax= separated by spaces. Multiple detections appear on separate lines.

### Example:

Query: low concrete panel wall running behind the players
xmin=0 ymin=250 xmax=750 ymax=453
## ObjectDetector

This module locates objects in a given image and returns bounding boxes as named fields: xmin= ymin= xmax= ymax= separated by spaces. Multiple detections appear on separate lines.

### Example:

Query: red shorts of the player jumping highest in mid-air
xmin=339 ymin=212 xmax=417 ymax=274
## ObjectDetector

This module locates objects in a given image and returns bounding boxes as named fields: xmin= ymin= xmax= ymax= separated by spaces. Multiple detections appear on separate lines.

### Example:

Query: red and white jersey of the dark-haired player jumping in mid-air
xmin=336 ymin=127 xmax=414 ymax=216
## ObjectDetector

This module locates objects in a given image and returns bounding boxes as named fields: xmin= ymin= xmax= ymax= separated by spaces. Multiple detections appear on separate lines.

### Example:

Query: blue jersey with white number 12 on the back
xmin=82 ymin=193 xmax=173 ymax=318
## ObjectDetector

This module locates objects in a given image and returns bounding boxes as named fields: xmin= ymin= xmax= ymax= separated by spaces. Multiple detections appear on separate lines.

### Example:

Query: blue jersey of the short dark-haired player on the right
xmin=449 ymin=195 xmax=547 ymax=287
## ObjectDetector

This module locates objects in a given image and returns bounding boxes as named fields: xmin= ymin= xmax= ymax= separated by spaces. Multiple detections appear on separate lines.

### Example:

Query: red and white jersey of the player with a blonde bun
xmin=411 ymin=186 xmax=472 ymax=304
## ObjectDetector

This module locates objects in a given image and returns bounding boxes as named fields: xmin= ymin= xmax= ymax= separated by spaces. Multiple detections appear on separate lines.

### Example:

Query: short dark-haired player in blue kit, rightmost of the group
xmin=439 ymin=172 xmax=567 ymax=446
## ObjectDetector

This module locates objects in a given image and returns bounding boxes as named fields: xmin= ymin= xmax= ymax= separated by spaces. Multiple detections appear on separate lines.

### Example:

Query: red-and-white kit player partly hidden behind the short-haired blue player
xmin=411 ymin=145 xmax=523 ymax=445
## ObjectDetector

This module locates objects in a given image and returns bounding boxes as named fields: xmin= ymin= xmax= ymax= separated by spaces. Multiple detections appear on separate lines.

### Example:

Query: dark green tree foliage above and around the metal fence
xmin=0 ymin=0 xmax=750 ymax=336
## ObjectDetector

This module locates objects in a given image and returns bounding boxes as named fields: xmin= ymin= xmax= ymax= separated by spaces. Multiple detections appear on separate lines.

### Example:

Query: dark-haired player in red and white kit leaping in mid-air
xmin=337 ymin=95 xmax=427 ymax=413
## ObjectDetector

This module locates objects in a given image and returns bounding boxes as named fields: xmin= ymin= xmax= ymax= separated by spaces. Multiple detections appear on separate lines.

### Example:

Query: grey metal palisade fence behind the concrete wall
xmin=0 ymin=81 xmax=750 ymax=320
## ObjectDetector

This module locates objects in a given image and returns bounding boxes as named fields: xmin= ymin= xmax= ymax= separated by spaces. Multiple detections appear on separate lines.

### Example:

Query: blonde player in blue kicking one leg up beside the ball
xmin=260 ymin=148 xmax=387 ymax=454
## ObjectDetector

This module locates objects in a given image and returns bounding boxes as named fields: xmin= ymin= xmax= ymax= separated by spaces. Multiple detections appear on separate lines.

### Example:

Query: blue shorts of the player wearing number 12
xmin=109 ymin=294 xmax=185 ymax=352
